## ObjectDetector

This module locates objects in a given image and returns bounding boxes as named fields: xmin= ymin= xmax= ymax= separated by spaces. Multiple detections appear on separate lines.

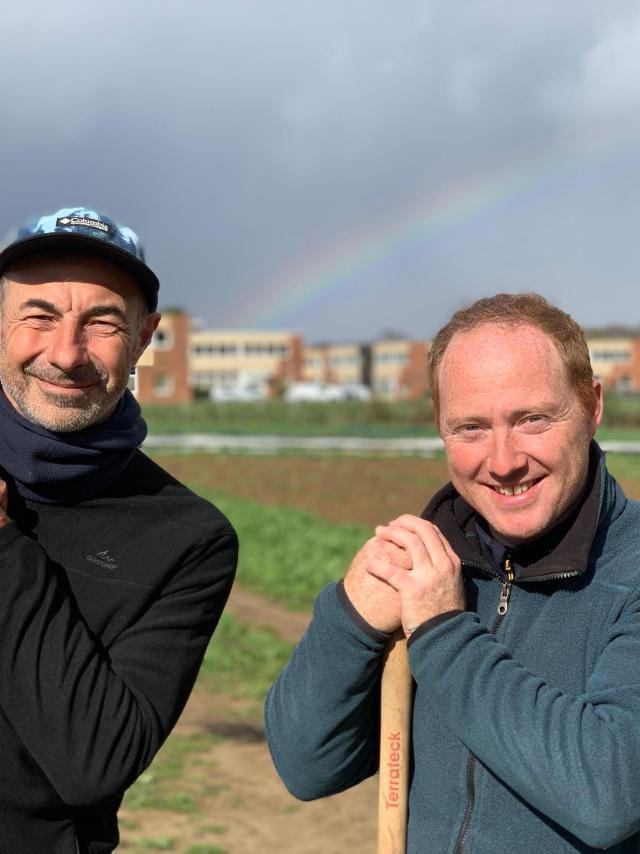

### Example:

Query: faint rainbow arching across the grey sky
xmin=245 ymin=136 xmax=638 ymax=328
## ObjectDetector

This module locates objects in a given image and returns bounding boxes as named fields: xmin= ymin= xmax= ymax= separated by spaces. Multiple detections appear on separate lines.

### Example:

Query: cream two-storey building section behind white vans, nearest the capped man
xmin=189 ymin=329 xmax=302 ymax=399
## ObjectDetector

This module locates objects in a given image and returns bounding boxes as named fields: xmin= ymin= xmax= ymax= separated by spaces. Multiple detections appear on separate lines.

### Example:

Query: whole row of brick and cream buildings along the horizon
xmin=132 ymin=310 xmax=640 ymax=403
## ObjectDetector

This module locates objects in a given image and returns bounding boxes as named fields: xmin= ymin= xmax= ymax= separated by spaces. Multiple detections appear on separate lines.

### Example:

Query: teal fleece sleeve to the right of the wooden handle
xmin=409 ymin=602 xmax=640 ymax=848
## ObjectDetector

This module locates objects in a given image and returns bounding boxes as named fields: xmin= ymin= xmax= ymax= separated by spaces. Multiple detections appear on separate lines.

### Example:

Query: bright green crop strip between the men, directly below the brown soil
xmin=194 ymin=484 xmax=373 ymax=610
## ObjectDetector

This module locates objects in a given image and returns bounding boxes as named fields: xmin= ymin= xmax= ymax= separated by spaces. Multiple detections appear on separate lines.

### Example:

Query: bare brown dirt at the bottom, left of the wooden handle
xmin=119 ymin=724 xmax=377 ymax=854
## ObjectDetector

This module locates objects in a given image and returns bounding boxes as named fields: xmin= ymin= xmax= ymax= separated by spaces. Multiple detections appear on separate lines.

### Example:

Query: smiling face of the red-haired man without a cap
xmin=439 ymin=324 xmax=602 ymax=545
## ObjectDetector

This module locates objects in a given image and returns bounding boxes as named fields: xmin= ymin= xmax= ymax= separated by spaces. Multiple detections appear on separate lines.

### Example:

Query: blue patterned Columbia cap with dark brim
xmin=0 ymin=208 xmax=160 ymax=311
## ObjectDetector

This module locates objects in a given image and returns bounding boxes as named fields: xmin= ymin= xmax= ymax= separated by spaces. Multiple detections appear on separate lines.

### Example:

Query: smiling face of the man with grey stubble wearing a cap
xmin=0 ymin=255 xmax=159 ymax=432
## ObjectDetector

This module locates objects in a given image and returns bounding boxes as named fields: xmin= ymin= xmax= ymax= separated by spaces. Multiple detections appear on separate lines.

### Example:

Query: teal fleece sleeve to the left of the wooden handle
xmin=265 ymin=584 xmax=386 ymax=800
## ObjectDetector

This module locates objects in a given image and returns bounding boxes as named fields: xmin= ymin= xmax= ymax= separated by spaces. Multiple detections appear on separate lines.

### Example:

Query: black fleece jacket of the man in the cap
xmin=0 ymin=452 xmax=237 ymax=854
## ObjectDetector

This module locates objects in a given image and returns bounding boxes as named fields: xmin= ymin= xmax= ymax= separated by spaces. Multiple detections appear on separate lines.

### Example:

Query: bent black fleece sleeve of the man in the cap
xmin=0 ymin=523 xmax=237 ymax=806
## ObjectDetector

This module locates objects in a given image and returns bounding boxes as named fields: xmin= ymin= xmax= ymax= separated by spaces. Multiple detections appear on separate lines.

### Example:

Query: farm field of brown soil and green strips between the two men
xmin=119 ymin=455 xmax=640 ymax=854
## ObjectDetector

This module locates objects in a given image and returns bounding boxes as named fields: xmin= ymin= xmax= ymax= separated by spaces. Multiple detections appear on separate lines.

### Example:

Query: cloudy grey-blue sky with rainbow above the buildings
xmin=0 ymin=0 xmax=640 ymax=342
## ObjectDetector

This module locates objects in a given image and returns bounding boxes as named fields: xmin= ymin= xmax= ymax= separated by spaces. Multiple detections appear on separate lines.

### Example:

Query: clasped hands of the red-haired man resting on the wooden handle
xmin=344 ymin=515 xmax=465 ymax=637
